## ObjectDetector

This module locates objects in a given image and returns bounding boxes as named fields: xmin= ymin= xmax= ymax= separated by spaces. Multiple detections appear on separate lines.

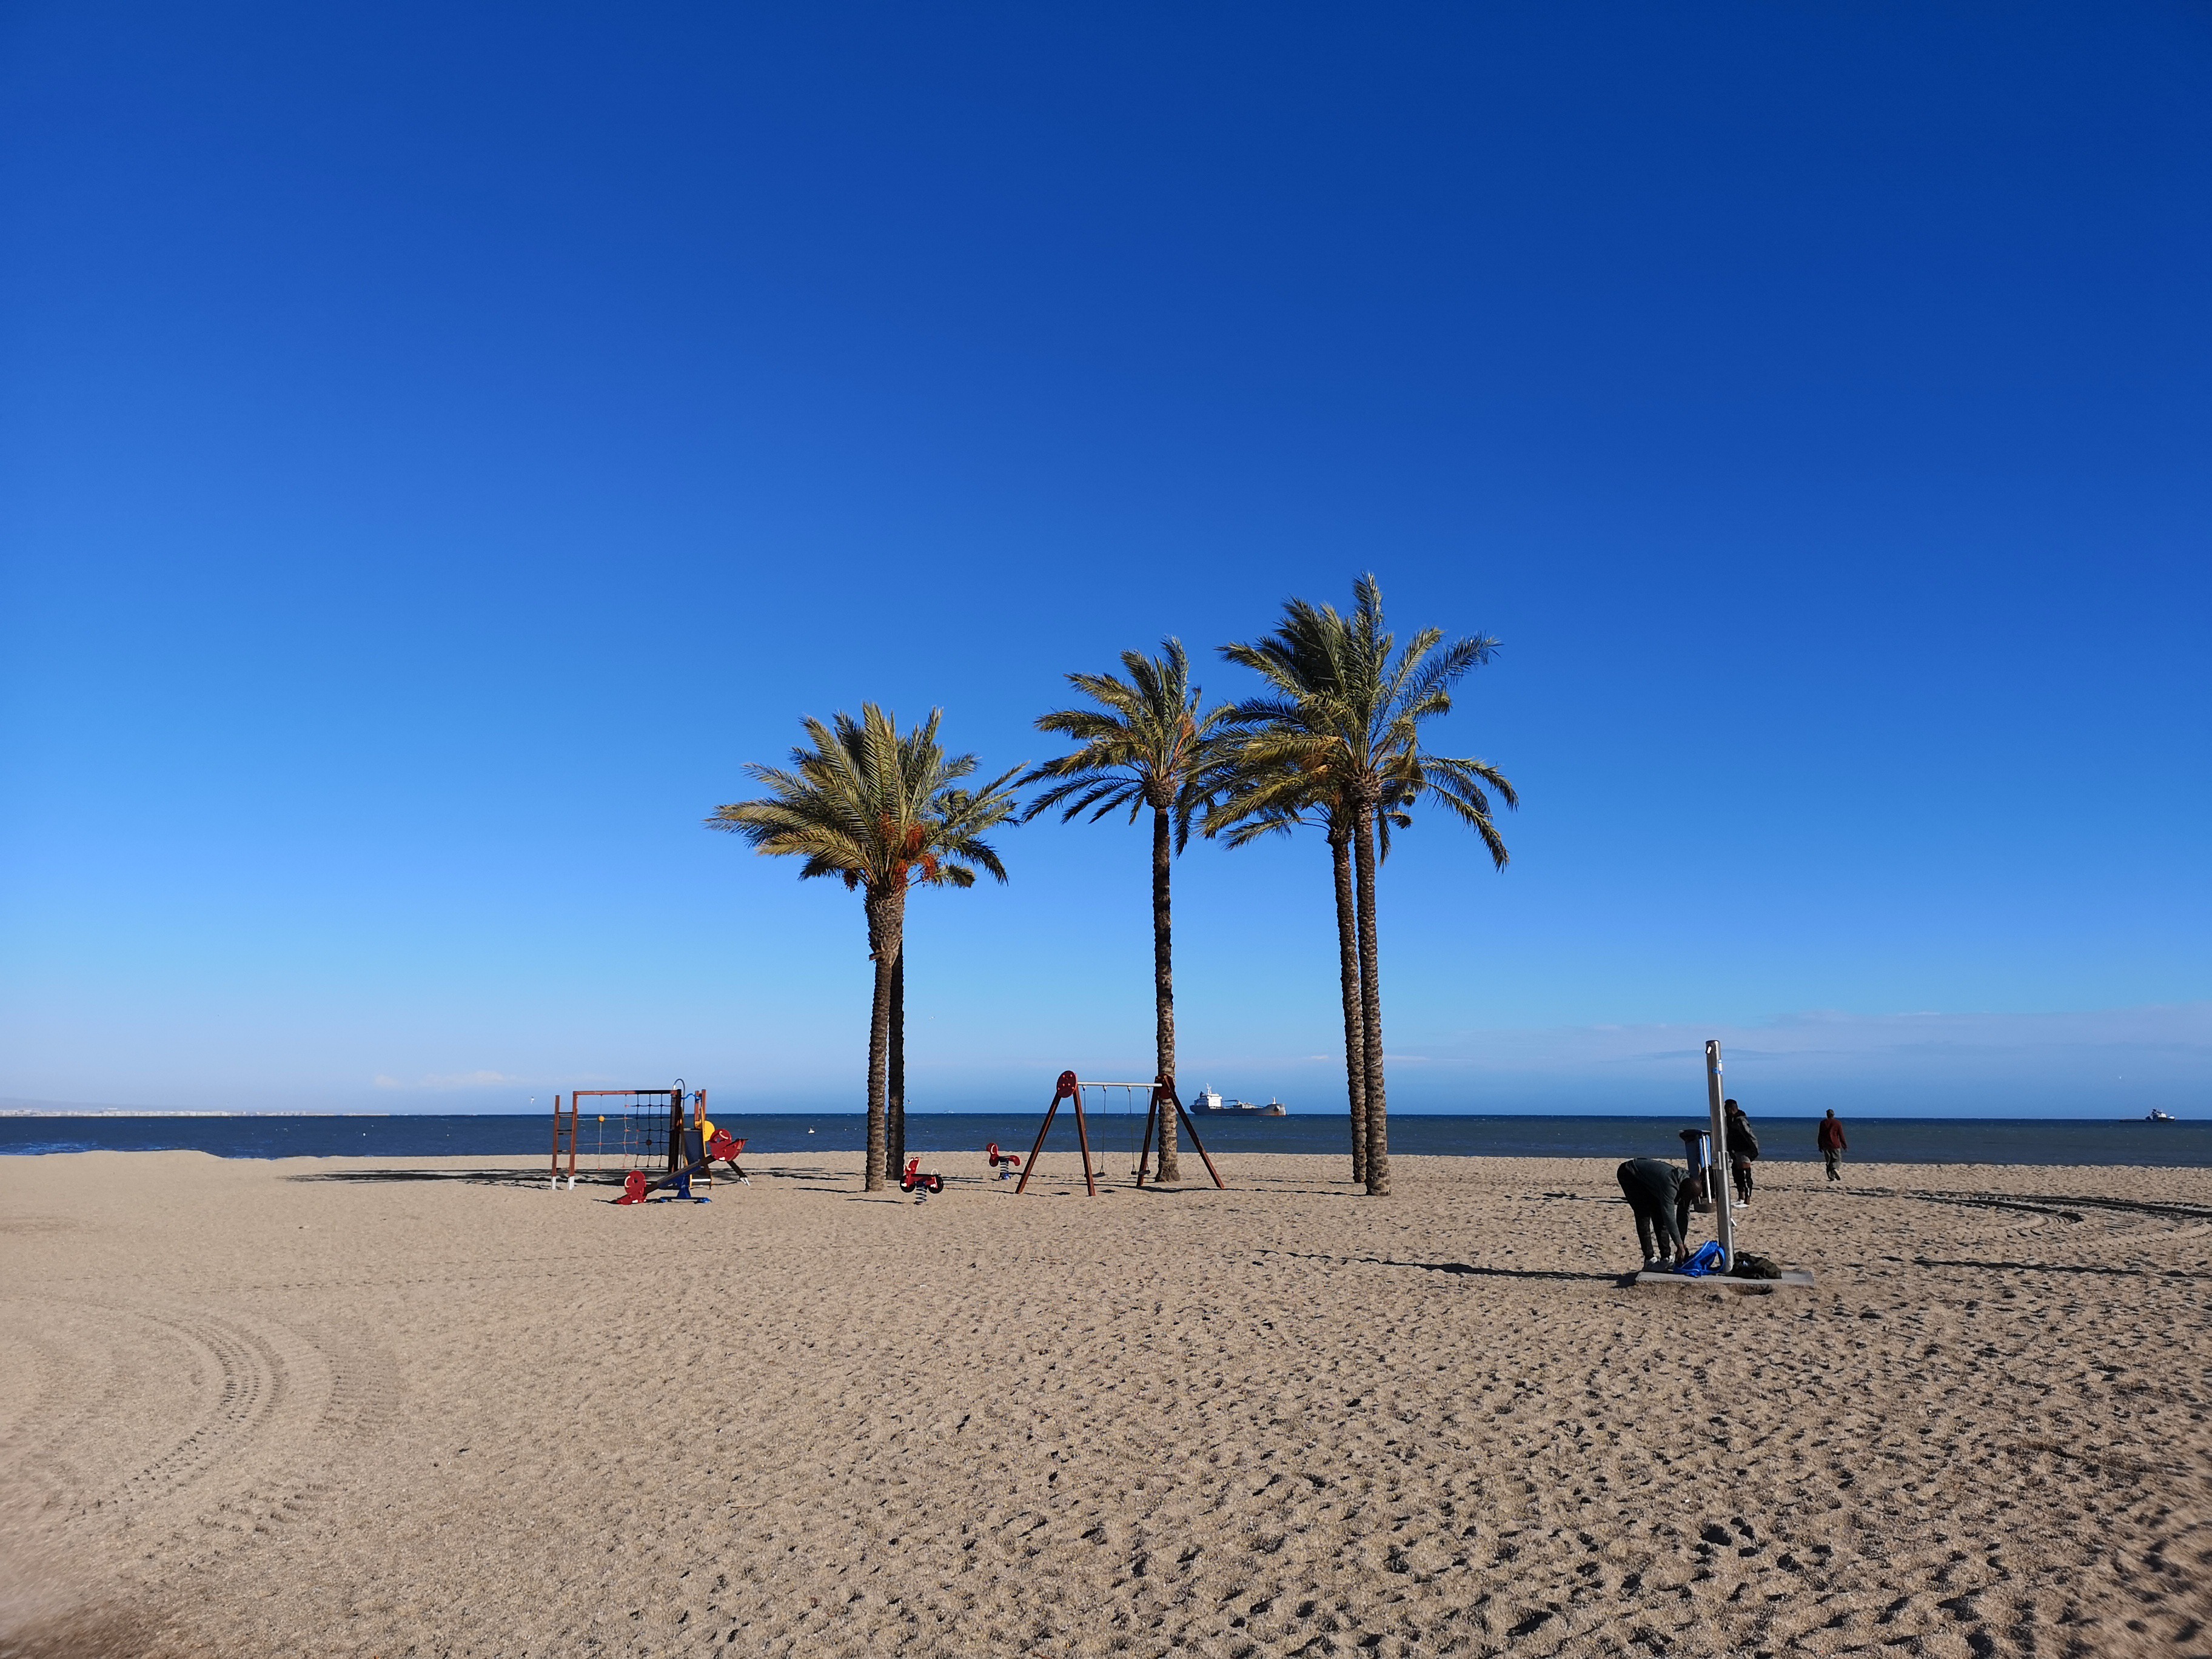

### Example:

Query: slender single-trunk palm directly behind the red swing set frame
xmin=1022 ymin=639 xmax=1223 ymax=1181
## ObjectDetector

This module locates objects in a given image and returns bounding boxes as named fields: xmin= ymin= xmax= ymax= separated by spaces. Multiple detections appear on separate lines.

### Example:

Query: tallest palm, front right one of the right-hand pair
xmin=1219 ymin=575 xmax=1520 ymax=1197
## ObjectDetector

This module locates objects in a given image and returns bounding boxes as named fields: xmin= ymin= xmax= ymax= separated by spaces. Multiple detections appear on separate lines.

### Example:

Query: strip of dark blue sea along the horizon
xmin=0 ymin=1108 xmax=2212 ymax=1168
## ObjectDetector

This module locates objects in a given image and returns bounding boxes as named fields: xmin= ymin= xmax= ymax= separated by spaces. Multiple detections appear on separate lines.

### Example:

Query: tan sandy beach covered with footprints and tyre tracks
xmin=0 ymin=1153 xmax=2212 ymax=1659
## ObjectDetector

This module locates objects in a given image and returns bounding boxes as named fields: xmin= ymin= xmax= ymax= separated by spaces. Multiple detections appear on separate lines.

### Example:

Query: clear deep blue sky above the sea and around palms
xmin=0 ymin=4 xmax=2212 ymax=1115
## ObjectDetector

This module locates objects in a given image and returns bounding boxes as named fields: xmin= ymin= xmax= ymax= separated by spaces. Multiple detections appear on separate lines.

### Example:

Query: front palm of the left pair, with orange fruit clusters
xmin=706 ymin=703 xmax=1020 ymax=1192
